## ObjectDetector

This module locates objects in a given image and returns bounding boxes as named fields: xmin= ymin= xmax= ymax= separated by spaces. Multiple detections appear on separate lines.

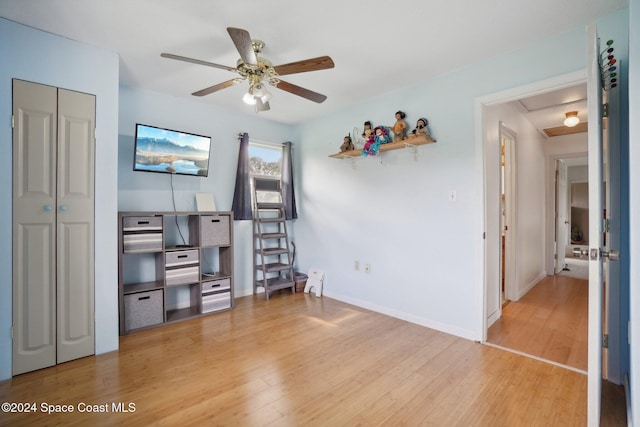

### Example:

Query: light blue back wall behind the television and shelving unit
xmin=118 ymin=87 xmax=296 ymax=297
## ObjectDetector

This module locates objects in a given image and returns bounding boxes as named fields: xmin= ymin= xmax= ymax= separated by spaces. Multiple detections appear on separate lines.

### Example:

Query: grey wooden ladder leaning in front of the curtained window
xmin=253 ymin=177 xmax=296 ymax=300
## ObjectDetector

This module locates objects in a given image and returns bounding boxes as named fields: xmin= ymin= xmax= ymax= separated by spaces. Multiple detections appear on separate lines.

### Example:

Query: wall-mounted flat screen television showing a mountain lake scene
xmin=133 ymin=123 xmax=211 ymax=176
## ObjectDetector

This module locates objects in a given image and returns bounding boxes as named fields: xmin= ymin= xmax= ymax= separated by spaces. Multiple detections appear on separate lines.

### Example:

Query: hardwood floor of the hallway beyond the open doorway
xmin=487 ymin=276 xmax=589 ymax=372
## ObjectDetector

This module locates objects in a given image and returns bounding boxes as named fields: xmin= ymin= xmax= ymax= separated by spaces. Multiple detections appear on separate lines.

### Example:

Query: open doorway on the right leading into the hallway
xmin=483 ymin=74 xmax=588 ymax=372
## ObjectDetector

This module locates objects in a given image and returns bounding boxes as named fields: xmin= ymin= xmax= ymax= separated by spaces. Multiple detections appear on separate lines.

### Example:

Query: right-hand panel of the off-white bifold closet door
xmin=57 ymin=89 xmax=95 ymax=363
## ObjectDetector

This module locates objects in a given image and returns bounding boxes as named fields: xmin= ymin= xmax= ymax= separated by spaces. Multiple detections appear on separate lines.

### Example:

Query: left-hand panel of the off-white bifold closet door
xmin=12 ymin=80 xmax=57 ymax=375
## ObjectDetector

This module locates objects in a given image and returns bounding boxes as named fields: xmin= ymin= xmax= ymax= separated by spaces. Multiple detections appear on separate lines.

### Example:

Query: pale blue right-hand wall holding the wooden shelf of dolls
xmin=295 ymin=11 xmax=627 ymax=339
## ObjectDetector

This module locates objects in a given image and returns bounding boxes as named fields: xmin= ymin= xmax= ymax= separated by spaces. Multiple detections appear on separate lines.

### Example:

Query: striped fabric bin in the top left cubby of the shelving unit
xmin=122 ymin=216 xmax=162 ymax=253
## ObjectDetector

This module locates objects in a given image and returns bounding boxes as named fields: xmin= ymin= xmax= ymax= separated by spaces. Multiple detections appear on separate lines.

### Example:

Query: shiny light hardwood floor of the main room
xmin=0 ymin=292 xmax=616 ymax=426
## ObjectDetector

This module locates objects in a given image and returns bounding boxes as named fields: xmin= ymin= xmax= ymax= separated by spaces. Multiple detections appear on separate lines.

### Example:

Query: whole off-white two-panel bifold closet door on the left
xmin=12 ymin=80 xmax=95 ymax=375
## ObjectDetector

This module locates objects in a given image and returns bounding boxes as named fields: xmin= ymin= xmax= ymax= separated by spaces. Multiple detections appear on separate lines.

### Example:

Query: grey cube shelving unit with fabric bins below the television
xmin=118 ymin=212 xmax=233 ymax=335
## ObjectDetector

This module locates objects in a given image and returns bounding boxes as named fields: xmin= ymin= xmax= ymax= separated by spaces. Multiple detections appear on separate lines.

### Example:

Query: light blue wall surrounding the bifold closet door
xmin=0 ymin=18 xmax=118 ymax=380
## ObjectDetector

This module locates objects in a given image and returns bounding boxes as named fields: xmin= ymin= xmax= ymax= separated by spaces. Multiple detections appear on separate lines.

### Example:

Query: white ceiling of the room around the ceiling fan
xmin=0 ymin=0 xmax=628 ymax=123
